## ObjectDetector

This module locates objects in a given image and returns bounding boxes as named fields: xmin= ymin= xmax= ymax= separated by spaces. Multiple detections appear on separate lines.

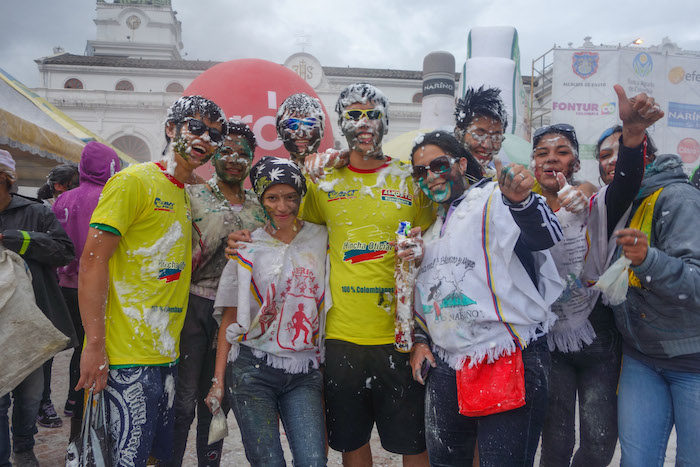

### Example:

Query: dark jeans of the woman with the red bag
xmin=425 ymin=338 xmax=550 ymax=467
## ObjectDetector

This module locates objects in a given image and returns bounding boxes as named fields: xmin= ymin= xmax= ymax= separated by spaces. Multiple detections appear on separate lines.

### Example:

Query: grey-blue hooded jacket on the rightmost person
xmin=613 ymin=154 xmax=700 ymax=373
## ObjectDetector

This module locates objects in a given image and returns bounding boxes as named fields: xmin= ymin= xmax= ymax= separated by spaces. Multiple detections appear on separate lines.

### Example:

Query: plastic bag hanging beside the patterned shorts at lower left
xmin=66 ymin=389 xmax=113 ymax=467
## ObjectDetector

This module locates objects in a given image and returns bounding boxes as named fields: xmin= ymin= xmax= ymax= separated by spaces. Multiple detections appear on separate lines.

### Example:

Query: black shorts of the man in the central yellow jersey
xmin=324 ymin=339 xmax=425 ymax=455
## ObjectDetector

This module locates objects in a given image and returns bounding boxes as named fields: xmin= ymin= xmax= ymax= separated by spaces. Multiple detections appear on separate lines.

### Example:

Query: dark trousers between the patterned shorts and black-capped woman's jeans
xmin=168 ymin=294 xmax=229 ymax=467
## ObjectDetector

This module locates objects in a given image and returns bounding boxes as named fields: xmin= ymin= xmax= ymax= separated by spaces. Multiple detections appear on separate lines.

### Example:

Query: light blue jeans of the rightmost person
xmin=617 ymin=355 xmax=700 ymax=467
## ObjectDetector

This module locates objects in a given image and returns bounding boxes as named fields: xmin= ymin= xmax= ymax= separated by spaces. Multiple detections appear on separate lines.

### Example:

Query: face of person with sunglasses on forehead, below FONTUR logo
xmin=532 ymin=133 xmax=579 ymax=192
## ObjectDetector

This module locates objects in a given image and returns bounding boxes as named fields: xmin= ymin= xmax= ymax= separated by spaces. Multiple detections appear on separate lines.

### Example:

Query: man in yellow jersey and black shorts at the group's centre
xmin=302 ymin=83 xmax=433 ymax=466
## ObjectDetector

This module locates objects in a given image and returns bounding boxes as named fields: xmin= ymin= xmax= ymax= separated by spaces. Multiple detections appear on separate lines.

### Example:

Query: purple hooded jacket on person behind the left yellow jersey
xmin=53 ymin=141 xmax=121 ymax=289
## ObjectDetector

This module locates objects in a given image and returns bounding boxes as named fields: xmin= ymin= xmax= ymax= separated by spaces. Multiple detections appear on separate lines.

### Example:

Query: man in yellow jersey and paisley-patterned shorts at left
xmin=77 ymin=96 xmax=226 ymax=465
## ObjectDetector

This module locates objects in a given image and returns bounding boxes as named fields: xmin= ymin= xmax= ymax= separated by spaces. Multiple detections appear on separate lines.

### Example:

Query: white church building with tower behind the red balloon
xmin=34 ymin=0 xmax=432 ymax=161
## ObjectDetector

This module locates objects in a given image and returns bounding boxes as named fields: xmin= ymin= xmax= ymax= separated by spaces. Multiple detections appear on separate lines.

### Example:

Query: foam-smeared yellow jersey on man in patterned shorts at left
xmin=90 ymin=163 xmax=192 ymax=368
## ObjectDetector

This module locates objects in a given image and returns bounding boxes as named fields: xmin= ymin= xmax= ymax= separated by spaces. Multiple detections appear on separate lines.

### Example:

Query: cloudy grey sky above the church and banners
xmin=0 ymin=0 xmax=700 ymax=87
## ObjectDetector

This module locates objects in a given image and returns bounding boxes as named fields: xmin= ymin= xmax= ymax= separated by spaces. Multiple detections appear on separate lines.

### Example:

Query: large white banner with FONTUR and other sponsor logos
xmin=552 ymin=48 xmax=700 ymax=183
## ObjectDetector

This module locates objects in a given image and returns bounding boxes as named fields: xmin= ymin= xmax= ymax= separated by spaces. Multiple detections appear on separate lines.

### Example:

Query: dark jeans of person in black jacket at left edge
xmin=0 ymin=366 xmax=44 ymax=466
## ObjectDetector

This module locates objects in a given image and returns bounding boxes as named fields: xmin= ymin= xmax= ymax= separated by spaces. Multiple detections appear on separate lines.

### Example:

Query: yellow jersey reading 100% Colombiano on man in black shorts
xmin=302 ymin=160 xmax=434 ymax=345
